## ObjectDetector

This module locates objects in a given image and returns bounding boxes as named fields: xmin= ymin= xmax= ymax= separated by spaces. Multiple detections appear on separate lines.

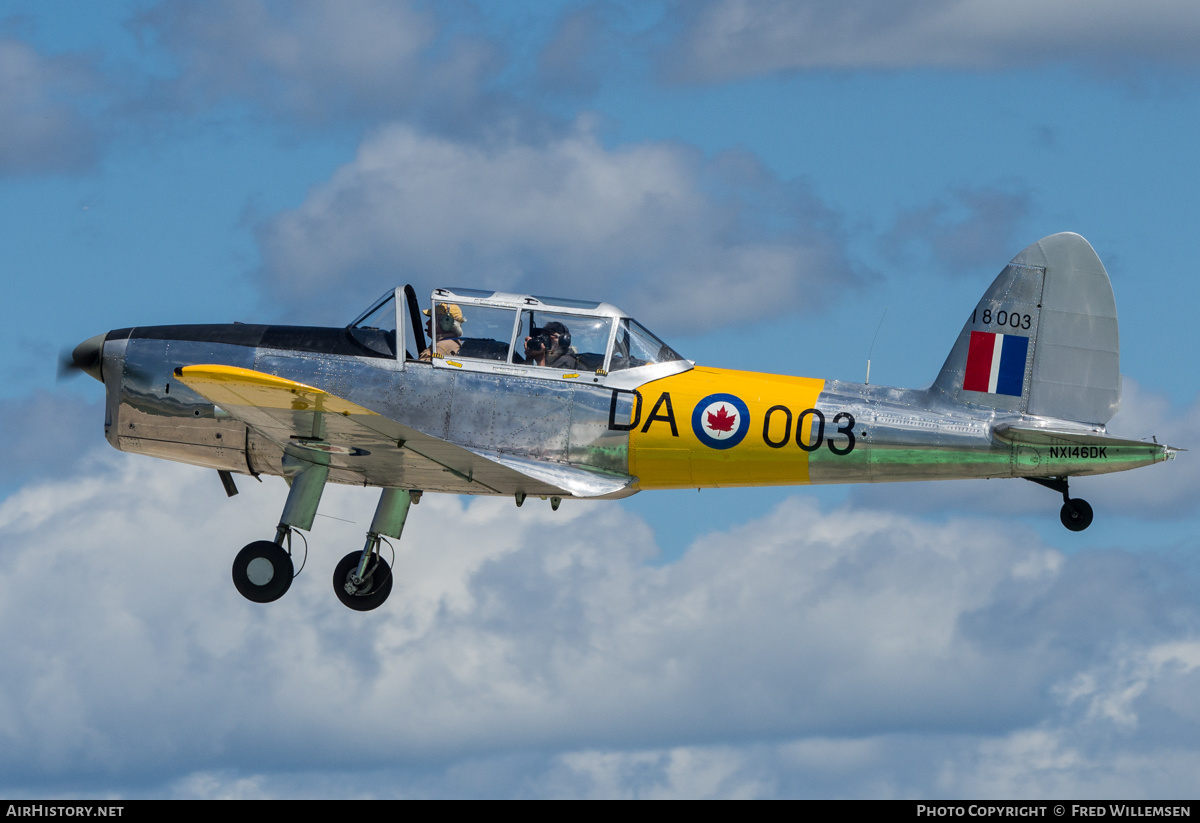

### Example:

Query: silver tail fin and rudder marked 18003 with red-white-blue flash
xmin=932 ymin=233 xmax=1121 ymax=426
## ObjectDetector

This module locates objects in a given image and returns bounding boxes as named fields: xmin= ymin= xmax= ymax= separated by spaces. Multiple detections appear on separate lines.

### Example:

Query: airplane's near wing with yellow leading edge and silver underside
xmin=175 ymin=365 xmax=634 ymax=497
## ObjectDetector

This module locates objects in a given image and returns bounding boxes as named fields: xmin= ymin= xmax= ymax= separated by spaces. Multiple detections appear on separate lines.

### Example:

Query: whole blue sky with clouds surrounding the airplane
xmin=0 ymin=0 xmax=1200 ymax=798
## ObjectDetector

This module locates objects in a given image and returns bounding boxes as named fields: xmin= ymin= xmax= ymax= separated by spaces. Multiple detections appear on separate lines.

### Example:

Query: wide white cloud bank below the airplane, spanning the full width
xmin=0 ymin=453 xmax=1200 ymax=797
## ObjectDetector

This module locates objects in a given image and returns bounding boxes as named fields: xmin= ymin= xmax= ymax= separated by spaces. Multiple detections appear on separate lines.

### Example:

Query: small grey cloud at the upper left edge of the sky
xmin=0 ymin=38 xmax=97 ymax=175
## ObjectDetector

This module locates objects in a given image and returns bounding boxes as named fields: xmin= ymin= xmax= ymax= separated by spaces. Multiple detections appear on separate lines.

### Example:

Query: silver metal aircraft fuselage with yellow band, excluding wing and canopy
xmin=88 ymin=324 xmax=1171 ymax=497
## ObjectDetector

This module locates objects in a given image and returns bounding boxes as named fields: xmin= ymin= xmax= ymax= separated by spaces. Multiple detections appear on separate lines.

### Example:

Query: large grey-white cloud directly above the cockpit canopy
xmin=259 ymin=126 xmax=860 ymax=331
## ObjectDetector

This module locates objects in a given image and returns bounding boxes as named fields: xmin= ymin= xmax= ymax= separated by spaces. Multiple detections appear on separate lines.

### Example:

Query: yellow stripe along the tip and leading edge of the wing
xmin=175 ymin=365 xmax=378 ymax=416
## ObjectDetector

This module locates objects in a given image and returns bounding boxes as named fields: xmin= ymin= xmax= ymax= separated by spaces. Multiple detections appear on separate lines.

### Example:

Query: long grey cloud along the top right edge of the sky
xmin=664 ymin=0 xmax=1200 ymax=82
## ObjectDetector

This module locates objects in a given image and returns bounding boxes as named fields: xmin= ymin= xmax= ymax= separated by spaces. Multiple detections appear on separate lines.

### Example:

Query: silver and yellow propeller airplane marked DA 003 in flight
xmin=68 ymin=233 xmax=1177 ymax=611
